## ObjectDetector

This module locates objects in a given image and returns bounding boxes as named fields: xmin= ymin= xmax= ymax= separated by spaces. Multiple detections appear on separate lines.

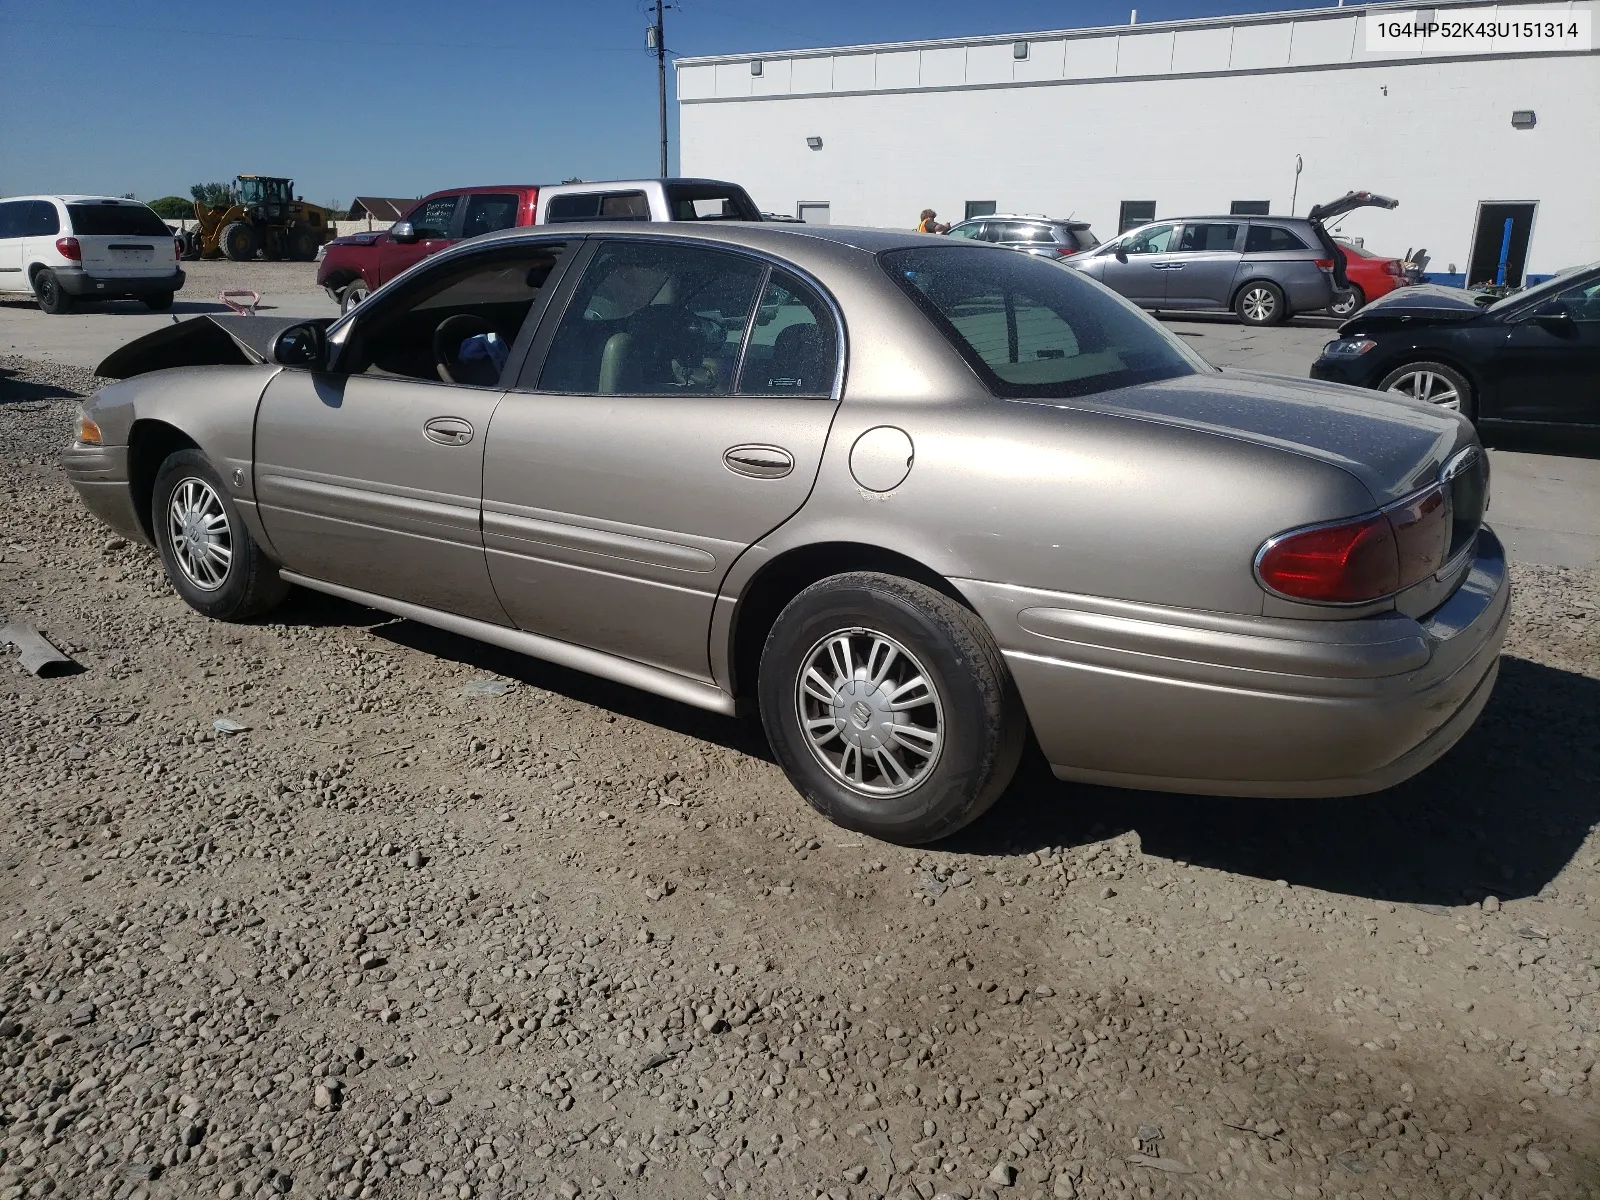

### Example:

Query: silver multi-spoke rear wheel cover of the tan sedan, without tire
xmin=795 ymin=629 xmax=944 ymax=800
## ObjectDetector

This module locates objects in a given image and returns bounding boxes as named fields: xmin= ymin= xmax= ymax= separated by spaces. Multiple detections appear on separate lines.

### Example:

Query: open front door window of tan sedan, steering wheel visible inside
xmin=339 ymin=242 xmax=566 ymax=387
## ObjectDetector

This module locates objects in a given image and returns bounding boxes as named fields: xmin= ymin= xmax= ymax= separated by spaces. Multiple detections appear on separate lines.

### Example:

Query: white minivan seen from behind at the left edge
xmin=0 ymin=195 xmax=184 ymax=312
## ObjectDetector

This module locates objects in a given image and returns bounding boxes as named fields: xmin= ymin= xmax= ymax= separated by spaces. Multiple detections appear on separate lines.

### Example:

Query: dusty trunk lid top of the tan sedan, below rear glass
xmin=1070 ymin=370 xmax=1474 ymax=504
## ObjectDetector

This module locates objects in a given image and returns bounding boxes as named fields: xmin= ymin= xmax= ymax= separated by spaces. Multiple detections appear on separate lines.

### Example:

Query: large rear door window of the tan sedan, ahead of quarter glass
xmin=539 ymin=242 xmax=765 ymax=395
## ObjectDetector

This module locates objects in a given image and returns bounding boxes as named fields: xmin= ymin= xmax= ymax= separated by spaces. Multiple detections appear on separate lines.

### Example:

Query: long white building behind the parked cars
xmin=677 ymin=0 xmax=1600 ymax=282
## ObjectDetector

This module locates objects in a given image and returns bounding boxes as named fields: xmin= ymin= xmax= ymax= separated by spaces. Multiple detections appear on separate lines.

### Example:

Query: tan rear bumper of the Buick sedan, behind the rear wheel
xmin=958 ymin=528 xmax=1510 ymax=797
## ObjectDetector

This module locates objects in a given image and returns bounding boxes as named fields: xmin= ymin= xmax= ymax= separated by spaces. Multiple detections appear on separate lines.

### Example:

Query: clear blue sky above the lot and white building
xmin=0 ymin=0 xmax=1350 ymax=203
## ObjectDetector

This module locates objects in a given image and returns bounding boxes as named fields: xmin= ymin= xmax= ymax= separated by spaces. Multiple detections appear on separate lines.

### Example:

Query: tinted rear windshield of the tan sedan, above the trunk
xmin=880 ymin=246 xmax=1210 ymax=398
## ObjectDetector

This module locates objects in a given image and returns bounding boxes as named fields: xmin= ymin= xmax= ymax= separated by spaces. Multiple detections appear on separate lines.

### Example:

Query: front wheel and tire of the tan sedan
xmin=150 ymin=450 xmax=288 ymax=621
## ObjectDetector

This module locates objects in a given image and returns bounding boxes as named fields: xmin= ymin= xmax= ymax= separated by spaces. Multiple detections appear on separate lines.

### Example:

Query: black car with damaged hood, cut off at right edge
xmin=1310 ymin=262 xmax=1600 ymax=426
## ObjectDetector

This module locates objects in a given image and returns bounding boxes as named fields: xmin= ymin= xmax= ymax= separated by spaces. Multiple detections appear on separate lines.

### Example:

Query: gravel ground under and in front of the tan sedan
xmin=0 ymin=360 xmax=1600 ymax=1200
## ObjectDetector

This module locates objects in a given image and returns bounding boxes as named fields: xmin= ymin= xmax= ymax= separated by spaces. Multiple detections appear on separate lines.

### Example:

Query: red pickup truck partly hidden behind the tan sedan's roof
xmin=317 ymin=184 xmax=539 ymax=312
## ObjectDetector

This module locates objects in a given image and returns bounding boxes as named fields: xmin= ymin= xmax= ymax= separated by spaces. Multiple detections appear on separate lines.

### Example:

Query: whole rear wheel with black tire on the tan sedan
xmin=757 ymin=571 xmax=1027 ymax=845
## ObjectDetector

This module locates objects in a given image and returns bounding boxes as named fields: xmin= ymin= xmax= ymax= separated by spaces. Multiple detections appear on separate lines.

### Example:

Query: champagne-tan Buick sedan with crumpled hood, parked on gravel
xmin=64 ymin=224 xmax=1509 ymax=843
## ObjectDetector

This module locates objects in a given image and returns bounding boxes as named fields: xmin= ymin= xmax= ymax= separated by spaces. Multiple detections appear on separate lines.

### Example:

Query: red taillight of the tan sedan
xmin=1256 ymin=485 xmax=1451 ymax=605
